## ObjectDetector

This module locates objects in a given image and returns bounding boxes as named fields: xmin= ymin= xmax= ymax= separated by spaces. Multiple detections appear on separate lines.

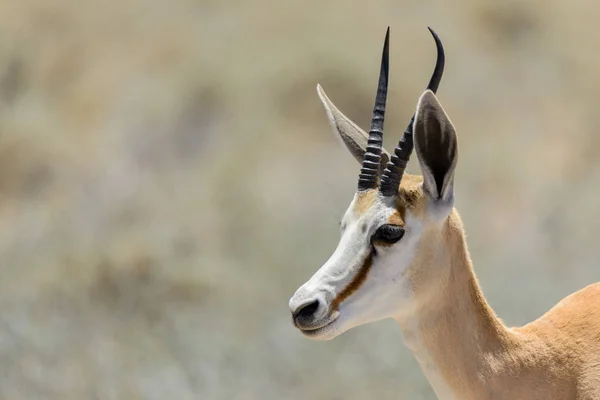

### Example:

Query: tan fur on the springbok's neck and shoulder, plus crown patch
xmin=398 ymin=178 xmax=600 ymax=400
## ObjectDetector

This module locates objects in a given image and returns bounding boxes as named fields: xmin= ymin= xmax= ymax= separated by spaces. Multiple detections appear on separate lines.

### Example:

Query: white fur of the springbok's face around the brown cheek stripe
xmin=289 ymin=192 xmax=422 ymax=340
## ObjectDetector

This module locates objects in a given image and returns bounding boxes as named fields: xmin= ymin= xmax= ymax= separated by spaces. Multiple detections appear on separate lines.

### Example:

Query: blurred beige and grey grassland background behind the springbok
xmin=0 ymin=0 xmax=600 ymax=400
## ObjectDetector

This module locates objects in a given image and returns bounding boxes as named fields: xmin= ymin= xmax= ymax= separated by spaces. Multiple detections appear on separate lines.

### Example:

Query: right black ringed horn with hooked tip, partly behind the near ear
xmin=380 ymin=27 xmax=446 ymax=197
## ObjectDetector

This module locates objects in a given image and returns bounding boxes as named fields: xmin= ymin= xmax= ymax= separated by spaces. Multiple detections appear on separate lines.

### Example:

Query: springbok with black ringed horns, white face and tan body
xmin=289 ymin=28 xmax=600 ymax=400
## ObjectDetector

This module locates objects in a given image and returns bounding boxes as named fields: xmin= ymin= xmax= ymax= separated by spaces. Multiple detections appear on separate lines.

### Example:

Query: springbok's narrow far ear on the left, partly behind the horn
xmin=317 ymin=85 xmax=390 ymax=173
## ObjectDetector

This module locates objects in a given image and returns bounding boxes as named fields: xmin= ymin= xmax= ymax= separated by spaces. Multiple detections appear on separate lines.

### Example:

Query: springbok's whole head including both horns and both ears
xmin=289 ymin=28 xmax=458 ymax=340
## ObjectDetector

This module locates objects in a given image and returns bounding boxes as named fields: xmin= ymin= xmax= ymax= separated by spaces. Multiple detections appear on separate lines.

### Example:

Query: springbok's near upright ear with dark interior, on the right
xmin=414 ymin=90 xmax=458 ymax=205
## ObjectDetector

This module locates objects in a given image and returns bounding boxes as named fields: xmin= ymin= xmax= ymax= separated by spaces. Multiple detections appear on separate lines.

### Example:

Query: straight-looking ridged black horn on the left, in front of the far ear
xmin=358 ymin=27 xmax=390 ymax=191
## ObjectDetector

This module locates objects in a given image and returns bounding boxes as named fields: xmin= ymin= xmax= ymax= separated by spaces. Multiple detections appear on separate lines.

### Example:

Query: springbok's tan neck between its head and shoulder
xmin=397 ymin=216 xmax=516 ymax=400
